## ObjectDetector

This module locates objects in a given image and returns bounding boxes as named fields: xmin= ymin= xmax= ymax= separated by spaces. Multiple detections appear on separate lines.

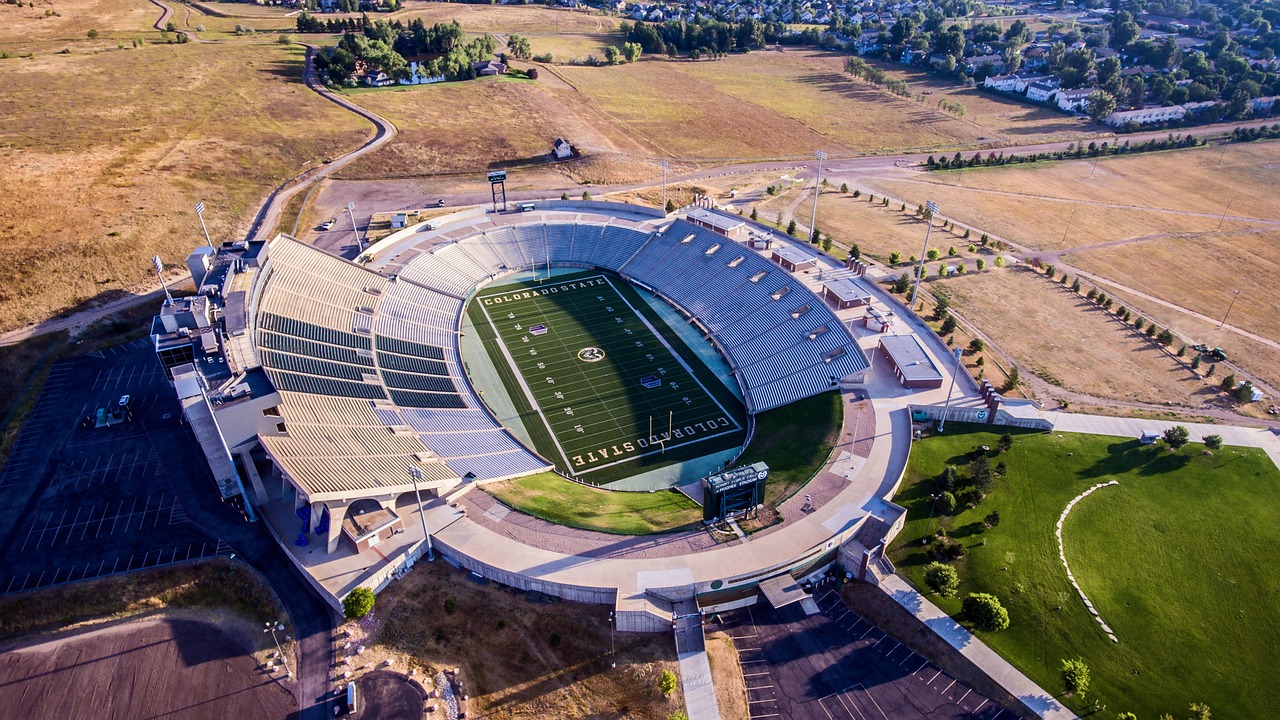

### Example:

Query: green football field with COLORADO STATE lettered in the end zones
xmin=475 ymin=274 xmax=742 ymax=483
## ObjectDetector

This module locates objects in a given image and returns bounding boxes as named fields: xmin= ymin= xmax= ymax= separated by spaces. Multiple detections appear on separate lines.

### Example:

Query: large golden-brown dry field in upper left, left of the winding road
xmin=0 ymin=18 xmax=371 ymax=329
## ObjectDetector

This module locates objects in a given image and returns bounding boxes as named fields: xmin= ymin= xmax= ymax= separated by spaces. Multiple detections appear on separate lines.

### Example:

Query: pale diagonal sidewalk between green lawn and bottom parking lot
xmin=879 ymin=575 xmax=1079 ymax=720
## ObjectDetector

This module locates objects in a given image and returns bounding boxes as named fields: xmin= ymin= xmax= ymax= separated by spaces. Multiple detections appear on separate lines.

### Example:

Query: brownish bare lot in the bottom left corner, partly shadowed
xmin=0 ymin=609 xmax=296 ymax=720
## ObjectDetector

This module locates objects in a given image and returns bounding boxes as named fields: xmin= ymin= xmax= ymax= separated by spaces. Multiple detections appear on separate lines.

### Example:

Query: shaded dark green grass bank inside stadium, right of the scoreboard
xmin=737 ymin=391 xmax=844 ymax=506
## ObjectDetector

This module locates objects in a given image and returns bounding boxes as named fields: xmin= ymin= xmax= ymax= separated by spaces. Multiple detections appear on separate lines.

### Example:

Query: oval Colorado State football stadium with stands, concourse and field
xmin=152 ymin=200 xmax=978 ymax=632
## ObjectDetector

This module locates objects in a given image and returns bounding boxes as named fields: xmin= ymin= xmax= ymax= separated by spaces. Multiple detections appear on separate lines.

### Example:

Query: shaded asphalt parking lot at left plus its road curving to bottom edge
xmin=0 ymin=340 xmax=335 ymax=720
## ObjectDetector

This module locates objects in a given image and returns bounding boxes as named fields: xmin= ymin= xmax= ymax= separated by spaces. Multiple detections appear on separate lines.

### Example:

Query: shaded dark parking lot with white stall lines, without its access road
xmin=0 ymin=340 xmax=229 ymax=593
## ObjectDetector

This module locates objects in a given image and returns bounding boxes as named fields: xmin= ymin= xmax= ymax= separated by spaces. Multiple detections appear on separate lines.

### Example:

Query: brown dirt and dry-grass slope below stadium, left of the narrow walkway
xmin=339 ymin=561 xmax=684 ymax=720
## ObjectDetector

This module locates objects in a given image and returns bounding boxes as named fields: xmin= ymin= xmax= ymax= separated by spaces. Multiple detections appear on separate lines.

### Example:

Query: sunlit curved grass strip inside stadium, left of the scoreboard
xmin=484 ymin=473 xmax=703 ymax=536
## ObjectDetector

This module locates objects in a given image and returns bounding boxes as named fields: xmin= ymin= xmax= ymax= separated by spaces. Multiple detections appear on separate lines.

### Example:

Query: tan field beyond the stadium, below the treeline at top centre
xmin=559 ymin=49 xmax=1078 ymax=160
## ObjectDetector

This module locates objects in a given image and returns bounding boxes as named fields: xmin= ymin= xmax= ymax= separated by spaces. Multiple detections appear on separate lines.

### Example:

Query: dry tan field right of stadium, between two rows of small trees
xmin=937 ymin=268 xmax=1217 ymax=406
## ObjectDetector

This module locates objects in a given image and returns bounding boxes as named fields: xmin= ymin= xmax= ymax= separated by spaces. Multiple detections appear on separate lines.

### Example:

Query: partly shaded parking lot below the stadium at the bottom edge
xmin=721 ymin=585 xmax=1016 ymax=720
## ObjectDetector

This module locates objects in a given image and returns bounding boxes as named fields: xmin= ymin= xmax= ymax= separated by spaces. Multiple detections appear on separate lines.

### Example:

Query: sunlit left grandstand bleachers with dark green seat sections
xmin=255 ymin=238 xmax=547 ymax=488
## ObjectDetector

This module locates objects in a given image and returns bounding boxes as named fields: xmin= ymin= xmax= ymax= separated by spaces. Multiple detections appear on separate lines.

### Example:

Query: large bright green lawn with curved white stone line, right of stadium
xmin=890 ymin=424 xmax=1280 ymax=717
